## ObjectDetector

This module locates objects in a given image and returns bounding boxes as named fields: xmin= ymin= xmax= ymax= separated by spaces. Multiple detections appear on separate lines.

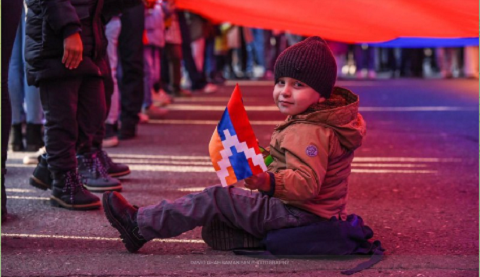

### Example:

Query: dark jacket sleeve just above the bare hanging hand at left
xmin=40 ymin=0 xmax=82 ymax=38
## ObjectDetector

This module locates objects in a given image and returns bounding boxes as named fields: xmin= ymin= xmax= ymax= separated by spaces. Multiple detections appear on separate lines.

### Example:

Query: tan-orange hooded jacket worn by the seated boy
xmin=269 ymin=87 xmax=366 ymax=218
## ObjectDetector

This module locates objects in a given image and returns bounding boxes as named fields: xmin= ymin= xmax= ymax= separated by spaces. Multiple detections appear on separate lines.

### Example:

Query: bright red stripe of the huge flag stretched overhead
xmin=177 ymin=0 xmax=479 ymax=43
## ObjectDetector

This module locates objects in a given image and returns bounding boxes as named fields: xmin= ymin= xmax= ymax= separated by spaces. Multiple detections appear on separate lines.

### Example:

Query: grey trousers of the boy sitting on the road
xmin=137 ymin=186 xmax=325 ymax=240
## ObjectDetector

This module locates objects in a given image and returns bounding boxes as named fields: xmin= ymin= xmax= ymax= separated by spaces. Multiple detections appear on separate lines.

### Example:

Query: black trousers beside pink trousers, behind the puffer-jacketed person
xmin=118 ymin=5 xmax=145 ymax=132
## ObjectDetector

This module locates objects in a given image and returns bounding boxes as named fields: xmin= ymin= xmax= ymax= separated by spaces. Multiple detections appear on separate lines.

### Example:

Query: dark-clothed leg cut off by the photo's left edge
xmin=1 ymin=0 xmax=23 ymax=214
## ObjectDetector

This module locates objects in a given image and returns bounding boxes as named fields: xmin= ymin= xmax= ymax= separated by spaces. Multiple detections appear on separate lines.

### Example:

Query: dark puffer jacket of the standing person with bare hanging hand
xmin=25 ymin=0 xmax=142 ymax=85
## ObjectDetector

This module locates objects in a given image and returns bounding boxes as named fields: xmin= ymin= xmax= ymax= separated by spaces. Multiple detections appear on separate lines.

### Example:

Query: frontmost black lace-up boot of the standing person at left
xmin=50 ymin=170 xmax=101 ymax=210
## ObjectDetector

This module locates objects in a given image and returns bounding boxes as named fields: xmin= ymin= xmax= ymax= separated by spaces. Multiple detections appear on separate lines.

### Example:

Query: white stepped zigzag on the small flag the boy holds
xmin=217 ymin=129 xmax=267 ymax=186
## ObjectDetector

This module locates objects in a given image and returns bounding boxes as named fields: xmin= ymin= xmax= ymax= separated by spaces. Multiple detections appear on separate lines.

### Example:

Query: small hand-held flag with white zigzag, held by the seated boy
xmin=208 ymin=84 xmax=267 ymax=186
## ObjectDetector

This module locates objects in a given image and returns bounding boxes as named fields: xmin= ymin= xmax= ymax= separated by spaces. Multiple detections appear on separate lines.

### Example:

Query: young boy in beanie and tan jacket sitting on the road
xmin=103 ymin=37 xmax=365 ymax=252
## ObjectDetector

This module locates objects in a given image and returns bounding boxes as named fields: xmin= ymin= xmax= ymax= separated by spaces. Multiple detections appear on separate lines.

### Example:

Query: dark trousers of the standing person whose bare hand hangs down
xmin=40 ymin=76 xmax=106 ymax=172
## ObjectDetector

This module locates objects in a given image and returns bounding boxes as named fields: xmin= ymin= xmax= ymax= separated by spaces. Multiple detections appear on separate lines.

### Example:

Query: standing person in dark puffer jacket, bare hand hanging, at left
xmin=25 ymin=0 xmax=142 ymax=209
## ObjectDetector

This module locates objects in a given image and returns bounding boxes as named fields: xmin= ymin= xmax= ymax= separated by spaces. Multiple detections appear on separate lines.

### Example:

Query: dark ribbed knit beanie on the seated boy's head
xmin=275 ymin=37 xmax=337 ymax=98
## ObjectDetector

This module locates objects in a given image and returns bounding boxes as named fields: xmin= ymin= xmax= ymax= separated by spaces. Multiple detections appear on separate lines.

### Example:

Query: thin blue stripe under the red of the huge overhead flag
xmin=368 ymin=37 xmax=478 ymax=48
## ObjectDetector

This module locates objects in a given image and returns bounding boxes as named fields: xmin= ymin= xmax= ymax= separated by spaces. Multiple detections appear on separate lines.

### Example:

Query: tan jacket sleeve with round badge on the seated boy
xmin=274 ymin=126 xmax=330 ymax=201
